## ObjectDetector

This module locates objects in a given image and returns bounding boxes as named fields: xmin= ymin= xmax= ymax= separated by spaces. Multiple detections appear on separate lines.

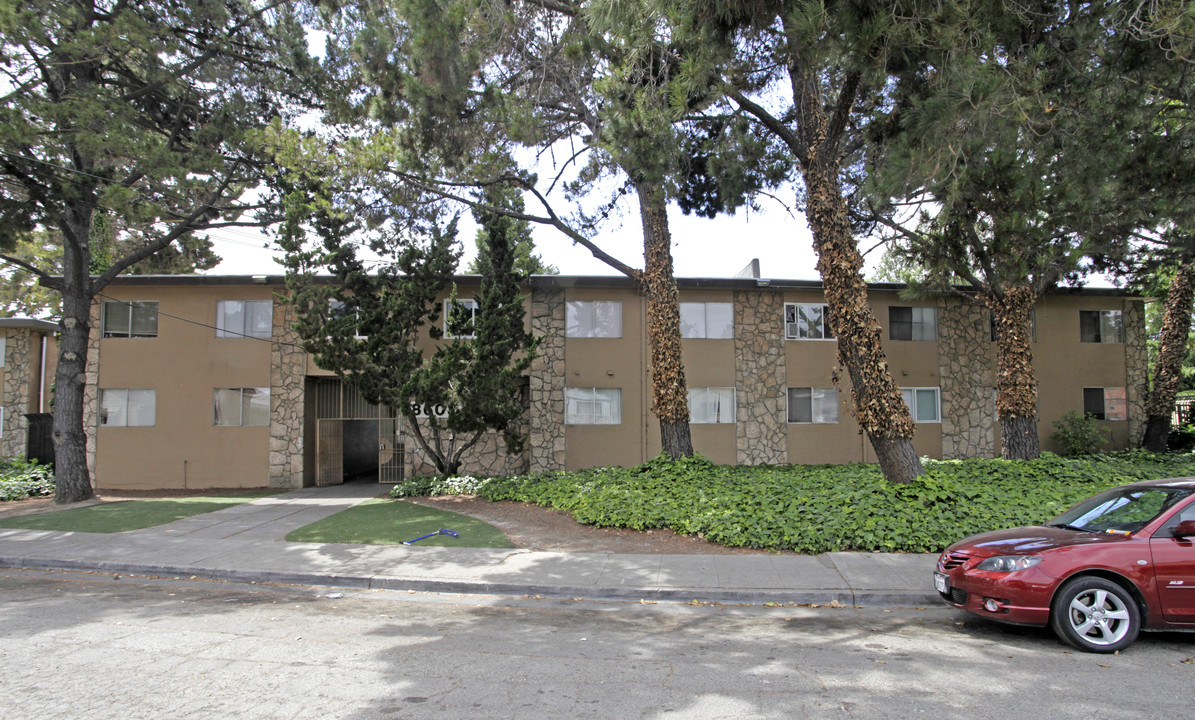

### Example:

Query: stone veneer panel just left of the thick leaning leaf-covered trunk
xmin=735 ymin=291 xmax=789 ymax=464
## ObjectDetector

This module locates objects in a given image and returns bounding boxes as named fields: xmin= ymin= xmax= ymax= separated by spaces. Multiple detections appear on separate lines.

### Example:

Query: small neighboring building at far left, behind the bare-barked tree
xmin=0 ymin=318 xmax=59 ymax=461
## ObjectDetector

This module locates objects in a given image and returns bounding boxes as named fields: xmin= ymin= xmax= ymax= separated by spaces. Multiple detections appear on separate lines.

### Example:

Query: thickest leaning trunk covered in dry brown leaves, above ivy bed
xmin=802 ymin=159 xmax=925 ymax=482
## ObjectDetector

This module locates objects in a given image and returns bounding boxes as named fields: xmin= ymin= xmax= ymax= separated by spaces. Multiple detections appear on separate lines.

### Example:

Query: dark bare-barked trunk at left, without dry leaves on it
xmin=54 ymin=203 xmax=94 ymax=503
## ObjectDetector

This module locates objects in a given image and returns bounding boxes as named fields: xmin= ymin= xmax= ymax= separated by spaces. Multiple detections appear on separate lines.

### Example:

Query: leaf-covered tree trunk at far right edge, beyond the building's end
xmin=1141 ymin=261 xmax=1195 ymax=453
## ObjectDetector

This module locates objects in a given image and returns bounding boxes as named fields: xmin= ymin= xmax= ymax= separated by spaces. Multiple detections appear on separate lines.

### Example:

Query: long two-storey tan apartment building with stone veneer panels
xmin=65 ymin=276 xmax=1146 ymax=488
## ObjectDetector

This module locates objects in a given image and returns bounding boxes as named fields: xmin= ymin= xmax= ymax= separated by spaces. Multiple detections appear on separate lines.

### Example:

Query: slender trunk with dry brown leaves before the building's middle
xmin=636 ymin=183 xmax=693 ymax=457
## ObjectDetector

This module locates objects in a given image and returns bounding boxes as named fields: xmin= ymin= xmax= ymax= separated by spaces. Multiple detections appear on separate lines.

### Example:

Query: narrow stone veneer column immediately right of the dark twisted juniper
xmin=527 ymin=289 xmax=568 ymax=473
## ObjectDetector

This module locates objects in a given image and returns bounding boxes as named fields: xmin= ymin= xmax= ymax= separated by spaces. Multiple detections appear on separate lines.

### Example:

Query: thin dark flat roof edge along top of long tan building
xmin=97 ymin=275 xmax=1144 ymax=297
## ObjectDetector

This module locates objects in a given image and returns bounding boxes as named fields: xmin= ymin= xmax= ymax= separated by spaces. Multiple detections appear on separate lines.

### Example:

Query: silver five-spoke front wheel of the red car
xmin=1049 ymin=576 xmax=1141 ymax=652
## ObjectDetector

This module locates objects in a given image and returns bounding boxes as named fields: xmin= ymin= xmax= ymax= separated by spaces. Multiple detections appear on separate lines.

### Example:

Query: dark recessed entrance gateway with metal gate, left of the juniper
xmin=307 ymin=377 xmax=406 ymax=487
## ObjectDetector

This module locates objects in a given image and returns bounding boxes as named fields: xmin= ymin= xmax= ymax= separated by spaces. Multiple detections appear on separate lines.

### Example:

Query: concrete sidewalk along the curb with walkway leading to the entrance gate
xmin=0 ymin=484 xmax=940 ymax=605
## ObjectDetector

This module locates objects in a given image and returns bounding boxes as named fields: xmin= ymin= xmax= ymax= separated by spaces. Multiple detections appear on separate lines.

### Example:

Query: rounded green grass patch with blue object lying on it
xmin=287 ymin=500 xmax=515 ymax=548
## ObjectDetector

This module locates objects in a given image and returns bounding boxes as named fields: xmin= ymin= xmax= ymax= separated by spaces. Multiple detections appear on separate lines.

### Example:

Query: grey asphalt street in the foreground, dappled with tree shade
xmin=0 ymin=570 xmax=1195 ymax=720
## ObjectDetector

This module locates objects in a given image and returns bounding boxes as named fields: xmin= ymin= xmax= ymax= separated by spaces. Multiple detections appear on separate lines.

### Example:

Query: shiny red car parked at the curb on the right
xmin=933 ymin=478 xmax=1195 ymax=652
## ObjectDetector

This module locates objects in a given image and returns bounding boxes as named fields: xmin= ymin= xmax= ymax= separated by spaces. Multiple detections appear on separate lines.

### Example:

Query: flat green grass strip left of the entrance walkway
xmin=0 ymin=491 xmax=281 ymax=533
